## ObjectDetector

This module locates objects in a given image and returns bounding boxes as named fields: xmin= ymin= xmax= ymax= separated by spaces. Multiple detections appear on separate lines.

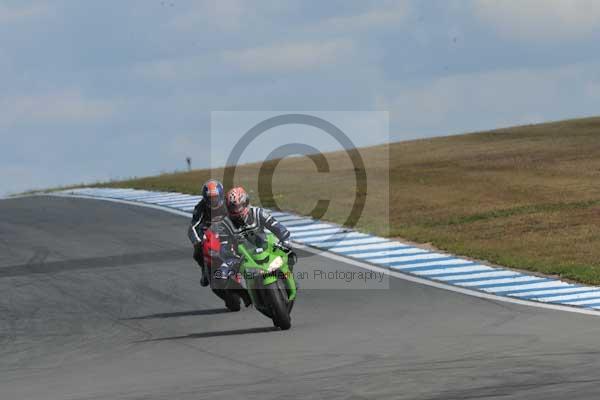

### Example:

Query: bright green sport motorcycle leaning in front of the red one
xmin=238 ymin=233 xmax=297 ymax=330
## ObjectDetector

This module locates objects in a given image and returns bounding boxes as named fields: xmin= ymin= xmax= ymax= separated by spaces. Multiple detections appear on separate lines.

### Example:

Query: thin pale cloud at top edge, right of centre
xmin=321 ymin=1 xmax=409 ymax=31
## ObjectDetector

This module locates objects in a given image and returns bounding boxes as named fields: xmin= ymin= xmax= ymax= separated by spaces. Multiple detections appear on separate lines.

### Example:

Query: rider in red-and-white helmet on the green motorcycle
xmin=215 ymin=187 xmax=296 ymax=306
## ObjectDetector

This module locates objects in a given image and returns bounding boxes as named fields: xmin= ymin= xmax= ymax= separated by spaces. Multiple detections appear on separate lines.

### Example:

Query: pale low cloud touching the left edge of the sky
xmin=0 ymin=90 xmax=113 ymax=126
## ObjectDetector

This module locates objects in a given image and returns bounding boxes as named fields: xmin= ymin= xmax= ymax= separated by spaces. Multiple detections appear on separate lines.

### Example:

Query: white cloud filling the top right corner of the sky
xmin=472 ymin=0 xmax=600 ymax=40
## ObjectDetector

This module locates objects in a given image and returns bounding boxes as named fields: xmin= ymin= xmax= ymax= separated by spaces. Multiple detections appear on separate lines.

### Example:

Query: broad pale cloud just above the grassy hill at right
xmin=378 ymin=64 xmax=599 ymax=134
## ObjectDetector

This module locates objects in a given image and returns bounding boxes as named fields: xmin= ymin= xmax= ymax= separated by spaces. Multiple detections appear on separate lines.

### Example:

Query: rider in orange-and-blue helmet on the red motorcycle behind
xmin=188 ymin=179 xmax=227 ymax=286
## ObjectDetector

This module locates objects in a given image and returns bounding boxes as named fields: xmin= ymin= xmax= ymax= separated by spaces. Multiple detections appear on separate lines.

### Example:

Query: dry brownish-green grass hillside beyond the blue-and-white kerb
xmin=71 ymin=118 xmax=600 ymax=284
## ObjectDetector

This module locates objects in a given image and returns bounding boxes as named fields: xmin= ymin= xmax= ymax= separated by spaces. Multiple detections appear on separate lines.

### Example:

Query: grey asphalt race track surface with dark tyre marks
xmin=0 ymin=197 xmax=600 ymax=400
